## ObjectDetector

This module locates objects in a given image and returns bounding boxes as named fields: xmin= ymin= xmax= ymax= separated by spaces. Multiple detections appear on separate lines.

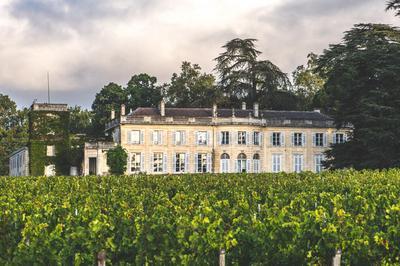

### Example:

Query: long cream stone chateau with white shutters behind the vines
xmin=84 ymin=102 xmax=348 ymax=174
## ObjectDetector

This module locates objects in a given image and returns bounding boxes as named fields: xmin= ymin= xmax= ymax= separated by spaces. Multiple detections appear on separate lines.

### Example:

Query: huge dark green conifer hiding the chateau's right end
xmin=318 ymin=24 xmax=400 ymax=169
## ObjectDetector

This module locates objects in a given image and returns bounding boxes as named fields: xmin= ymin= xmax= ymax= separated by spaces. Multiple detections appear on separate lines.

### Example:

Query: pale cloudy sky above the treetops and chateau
xmin=0 ymin=0 xmax=400 ymax=107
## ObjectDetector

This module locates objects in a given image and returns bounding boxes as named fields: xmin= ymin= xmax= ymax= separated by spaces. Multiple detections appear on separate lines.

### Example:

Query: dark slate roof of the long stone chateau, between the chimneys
xmin=128 ymin=107 xmax=333 ymax=121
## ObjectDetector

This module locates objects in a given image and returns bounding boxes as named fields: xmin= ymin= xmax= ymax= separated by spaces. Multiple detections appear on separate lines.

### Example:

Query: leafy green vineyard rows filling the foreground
xmin=0 ymin=170 xmax=400 ymax=265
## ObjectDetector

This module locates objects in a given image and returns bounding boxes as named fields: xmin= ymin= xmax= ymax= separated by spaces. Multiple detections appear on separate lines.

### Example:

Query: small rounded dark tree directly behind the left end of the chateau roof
xmin=125 ymin=73 xmax=162 ymax=110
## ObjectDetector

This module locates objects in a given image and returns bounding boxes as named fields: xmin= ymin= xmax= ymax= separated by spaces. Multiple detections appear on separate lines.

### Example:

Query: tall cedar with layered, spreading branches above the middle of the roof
xmin=214 ymin=38 xmax=290 ymax=108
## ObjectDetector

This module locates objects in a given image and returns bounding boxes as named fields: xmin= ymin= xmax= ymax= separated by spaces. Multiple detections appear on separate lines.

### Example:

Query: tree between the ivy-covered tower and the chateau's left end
xmin=90 ymin=82 xmax=127 ymax=137
